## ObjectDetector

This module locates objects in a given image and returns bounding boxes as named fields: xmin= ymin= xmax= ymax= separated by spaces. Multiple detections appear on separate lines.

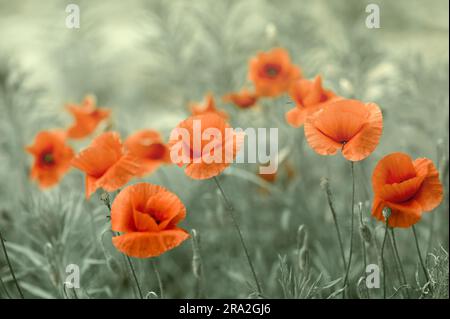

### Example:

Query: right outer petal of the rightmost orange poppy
xmin=414 ymin=158 xmax=444 ymax=212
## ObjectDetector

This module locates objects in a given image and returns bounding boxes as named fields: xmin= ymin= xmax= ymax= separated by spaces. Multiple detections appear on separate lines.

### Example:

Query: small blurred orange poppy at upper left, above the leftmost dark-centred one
xmin=66 ymin=96 xmax=111 ymax=139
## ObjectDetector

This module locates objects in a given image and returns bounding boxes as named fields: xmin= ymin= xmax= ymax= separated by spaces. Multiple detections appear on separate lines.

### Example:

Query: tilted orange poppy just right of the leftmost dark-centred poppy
xmin=72 ymin=132 xmax=139 ymax=198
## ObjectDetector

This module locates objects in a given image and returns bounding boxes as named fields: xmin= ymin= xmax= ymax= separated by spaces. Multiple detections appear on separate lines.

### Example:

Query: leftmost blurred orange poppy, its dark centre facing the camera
xmin=25 ymin=131 xmax=74 ymax=188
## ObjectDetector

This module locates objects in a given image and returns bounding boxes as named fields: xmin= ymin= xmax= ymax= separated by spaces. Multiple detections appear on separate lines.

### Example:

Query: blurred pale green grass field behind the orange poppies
xmin=0 ymin=0 xmax=449 ymax=298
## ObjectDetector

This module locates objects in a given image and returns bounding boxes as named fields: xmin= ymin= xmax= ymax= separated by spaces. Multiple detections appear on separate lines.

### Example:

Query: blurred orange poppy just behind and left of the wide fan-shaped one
xmin=286 ymin=76 xmax=338 ymax=127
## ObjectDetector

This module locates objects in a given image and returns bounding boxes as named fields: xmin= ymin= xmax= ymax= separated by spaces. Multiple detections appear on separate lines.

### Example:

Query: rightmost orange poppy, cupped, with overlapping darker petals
xmin=372 ymin=153 xmax=443 ymax=227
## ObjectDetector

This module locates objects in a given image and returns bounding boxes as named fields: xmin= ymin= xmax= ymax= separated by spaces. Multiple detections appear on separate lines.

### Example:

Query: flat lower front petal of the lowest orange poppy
xmin=112 ymin=228 xmax=189 ymax=258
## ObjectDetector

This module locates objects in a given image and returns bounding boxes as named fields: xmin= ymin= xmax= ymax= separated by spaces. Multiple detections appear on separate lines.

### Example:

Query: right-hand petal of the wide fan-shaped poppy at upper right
xmin=342 ymin=103 xmax=383 ymax=161
